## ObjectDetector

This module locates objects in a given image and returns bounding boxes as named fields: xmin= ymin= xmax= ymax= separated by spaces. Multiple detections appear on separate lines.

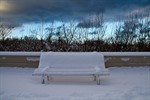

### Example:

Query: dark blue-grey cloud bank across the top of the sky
xmin=0 ymin=0 xmax=150 ymax=24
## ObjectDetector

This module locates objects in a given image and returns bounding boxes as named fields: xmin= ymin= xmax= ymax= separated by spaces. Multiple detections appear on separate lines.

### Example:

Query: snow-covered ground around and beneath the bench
xmin=0 ymin=67 xmax=150 ymax=100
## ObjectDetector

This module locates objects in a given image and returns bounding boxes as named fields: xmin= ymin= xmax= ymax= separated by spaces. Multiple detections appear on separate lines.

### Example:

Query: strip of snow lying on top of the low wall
xmin=0 ymin=52 xmax=150 ymax=56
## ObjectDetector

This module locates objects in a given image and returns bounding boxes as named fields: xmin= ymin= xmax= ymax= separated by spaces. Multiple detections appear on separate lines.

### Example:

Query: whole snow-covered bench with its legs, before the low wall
xmin=33 ymin=52 xmax=109 ymax=85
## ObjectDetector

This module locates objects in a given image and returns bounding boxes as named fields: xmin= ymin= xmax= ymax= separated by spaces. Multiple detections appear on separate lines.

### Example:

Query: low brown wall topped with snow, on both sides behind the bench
xmin=0 ymin=52 xmax=150 ymax=68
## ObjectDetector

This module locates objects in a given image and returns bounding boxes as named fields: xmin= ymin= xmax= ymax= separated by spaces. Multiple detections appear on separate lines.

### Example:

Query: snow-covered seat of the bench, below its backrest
xmin=33 ymin=68 xmax=109 ymax=76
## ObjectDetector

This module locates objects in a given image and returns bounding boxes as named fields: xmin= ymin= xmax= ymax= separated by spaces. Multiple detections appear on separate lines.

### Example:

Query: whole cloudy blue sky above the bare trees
xmin=0 ymin=0 xmax=150 ymax=37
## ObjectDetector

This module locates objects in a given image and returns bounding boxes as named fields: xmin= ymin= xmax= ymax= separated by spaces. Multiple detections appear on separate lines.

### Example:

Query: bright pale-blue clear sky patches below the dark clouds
xmin=8 ymin=21 xmax=120 ymax=39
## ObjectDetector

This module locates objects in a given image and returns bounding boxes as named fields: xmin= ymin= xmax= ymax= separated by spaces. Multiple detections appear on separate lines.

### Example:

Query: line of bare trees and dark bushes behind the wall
xmin=0 ymin=13 xmax=150 ymax=52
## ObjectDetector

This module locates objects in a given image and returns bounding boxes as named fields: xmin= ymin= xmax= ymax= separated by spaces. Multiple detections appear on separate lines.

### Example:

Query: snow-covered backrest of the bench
xmin=39 ymin=52 xmax=105 ymax=69
